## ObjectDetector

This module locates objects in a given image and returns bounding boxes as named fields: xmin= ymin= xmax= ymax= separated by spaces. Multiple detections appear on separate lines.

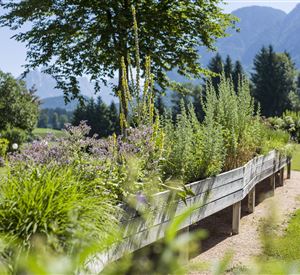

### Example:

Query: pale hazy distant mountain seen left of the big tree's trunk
xmin=23 ymin=70 xmax=116 ymax=107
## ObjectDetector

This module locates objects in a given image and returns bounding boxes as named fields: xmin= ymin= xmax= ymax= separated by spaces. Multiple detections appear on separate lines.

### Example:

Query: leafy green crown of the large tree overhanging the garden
xmin=0 ymin=0 xmax=234 ymax=101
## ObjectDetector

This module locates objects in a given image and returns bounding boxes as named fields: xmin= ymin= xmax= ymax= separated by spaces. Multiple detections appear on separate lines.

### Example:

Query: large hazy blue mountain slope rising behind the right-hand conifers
xmin=199 ymin=4 xmax=300 ymax=71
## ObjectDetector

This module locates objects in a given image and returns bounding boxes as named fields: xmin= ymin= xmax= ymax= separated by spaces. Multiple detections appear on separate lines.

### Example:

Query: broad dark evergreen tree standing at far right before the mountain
xmin=252 ymin=46 xmax=296 ymax=116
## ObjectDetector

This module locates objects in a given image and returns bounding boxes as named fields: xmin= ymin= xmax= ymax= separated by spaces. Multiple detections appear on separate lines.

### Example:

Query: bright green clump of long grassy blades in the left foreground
xmin=0 ymin=166 xmax=115 ymax=252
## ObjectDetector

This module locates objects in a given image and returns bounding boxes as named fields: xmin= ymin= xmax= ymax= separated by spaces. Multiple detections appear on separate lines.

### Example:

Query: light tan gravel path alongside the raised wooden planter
xmin=190 ymin=171 xmax=300 ymax=275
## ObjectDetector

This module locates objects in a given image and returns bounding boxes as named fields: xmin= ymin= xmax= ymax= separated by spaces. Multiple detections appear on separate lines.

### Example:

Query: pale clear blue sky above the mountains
xmin=0 ymin=0 xmax=300 ymax=77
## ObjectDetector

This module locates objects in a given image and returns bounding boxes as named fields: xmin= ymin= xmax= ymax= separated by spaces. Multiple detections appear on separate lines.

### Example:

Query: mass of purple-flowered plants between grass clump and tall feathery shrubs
xmin=10 ymin=122 xmax=163 ymax=200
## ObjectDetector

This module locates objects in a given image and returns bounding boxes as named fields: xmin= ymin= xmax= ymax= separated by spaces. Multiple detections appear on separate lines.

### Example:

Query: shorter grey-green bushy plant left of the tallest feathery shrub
xmin=163 ymin=101 xmax=224 ymax=182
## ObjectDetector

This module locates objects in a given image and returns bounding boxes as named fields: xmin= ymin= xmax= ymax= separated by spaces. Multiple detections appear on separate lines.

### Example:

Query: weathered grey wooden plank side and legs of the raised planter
xmin=90 ymin=151 xmax=290 ymax=271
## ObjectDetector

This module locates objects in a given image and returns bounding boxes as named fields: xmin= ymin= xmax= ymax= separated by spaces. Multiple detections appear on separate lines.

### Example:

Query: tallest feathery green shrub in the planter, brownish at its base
xmin=204 ymin=75 xmax=261 ymax=170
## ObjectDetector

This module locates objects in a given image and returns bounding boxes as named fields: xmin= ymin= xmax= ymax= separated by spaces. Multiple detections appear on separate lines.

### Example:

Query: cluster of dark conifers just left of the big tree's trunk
xmin=72 ymin=97 xmax=120 ymax=137
